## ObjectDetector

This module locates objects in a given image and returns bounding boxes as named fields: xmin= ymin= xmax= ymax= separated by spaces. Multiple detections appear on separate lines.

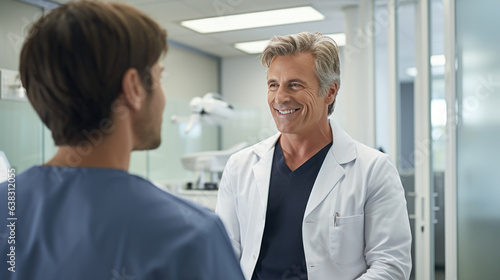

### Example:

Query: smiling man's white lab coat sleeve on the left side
xmin=215 ymin=157 xmax=241 ymax=260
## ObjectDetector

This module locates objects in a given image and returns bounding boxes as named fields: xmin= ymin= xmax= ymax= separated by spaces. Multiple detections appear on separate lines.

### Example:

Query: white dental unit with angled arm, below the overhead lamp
xmin=181 ymin=142 xmax=248 ymax=190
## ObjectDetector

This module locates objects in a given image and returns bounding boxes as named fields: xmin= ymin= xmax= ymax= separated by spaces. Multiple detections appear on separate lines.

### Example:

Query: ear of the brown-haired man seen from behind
xmin=121 ymin=68 xmax=147 ymax=111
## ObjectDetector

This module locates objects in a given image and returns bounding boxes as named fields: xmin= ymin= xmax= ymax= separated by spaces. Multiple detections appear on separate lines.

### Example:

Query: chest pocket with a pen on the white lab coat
xmin=329 ymin=214 xmax=364 ymax=264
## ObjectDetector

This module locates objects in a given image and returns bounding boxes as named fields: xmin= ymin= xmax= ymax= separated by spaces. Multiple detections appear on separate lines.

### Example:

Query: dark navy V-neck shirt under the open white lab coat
xmin=252 ymin=141 xmax=332 ymax=280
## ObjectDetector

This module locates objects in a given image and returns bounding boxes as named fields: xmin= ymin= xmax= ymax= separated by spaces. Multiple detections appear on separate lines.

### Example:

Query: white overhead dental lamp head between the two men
xmin=171 ymin=92 xmax=233 ymax=133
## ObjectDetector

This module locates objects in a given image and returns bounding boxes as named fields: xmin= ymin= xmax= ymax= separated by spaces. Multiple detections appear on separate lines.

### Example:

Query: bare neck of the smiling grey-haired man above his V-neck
xmin=280 ymin=121 xmax=333 ymax=171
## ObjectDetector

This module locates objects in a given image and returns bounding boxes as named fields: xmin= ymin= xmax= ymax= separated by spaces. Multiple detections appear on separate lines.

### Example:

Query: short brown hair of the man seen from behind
xmin=20 ymin=1 xmax=167 ymax=146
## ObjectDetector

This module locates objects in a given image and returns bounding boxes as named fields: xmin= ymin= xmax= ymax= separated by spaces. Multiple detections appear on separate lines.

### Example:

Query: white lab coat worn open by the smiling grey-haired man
xmin=216 ymin=122 xmax=411 ymax=280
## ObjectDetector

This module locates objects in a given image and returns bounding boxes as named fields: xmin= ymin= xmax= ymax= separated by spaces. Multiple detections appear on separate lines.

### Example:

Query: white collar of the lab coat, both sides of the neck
xmin=254 ymin=120 xmax=357 ymax=164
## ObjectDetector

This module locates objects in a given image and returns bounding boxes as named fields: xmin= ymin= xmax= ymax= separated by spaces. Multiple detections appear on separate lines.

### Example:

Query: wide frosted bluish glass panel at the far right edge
xmin=456 ymin=0 xmax=500 ymax=279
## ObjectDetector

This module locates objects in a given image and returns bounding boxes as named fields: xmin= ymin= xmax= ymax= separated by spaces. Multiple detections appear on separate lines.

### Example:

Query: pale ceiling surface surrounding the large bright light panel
xmin=58 ymin=0 xmax=359 ymax=57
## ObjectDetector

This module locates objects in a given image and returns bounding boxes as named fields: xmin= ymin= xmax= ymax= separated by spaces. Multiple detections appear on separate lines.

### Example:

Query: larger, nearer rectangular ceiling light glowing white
xmin=181 ymin=6 xmax=325 ymax=33
